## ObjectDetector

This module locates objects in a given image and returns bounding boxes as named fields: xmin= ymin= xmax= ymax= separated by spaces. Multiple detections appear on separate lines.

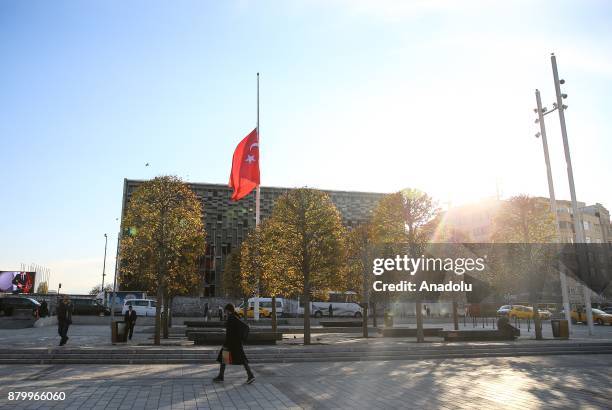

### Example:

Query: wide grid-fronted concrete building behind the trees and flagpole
xmin=121 ymin=179 xmax=384 ymax=296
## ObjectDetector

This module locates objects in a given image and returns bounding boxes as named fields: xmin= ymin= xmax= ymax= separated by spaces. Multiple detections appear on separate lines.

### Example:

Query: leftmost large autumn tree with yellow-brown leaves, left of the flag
xmin=119 ymin=176 xmax=206 ymax=345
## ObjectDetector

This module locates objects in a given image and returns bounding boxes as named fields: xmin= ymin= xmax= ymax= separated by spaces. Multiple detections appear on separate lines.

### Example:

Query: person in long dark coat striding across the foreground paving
xmin=213 ymin=303 xmax=255 ymax=384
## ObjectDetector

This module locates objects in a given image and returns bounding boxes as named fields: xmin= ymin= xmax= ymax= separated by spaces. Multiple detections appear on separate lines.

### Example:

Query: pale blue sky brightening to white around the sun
xmin=0 ymin=0 xmax=612 ymax=293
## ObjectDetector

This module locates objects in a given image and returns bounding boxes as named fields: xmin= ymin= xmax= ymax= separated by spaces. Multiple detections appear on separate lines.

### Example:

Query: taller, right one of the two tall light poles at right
xmin=550 ymin=53 xmax=593 ymax=335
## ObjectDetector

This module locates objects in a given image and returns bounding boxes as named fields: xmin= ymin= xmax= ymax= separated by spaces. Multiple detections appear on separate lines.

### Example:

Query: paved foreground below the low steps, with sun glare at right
xmin=0 ymin=355 xmax=612 ymax=410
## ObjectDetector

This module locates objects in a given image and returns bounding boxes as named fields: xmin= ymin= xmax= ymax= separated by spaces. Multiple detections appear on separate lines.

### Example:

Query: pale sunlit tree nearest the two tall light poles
xmin=492 ymin=195 xmax=556 ymax=340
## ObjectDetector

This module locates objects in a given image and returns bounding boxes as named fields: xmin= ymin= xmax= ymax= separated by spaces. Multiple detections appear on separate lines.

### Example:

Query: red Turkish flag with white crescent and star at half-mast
xmin=229 ymin=128 xmax=259 ymax=201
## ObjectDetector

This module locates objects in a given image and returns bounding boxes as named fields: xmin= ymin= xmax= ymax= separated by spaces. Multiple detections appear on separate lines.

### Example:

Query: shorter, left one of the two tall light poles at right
xmin=534 ymin=90 xmax=572 ymax=333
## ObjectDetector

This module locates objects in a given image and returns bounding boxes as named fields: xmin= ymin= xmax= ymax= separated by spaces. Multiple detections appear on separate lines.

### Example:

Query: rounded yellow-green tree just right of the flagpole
xmin=265 ymin=188 xmax=346 ymax=344
